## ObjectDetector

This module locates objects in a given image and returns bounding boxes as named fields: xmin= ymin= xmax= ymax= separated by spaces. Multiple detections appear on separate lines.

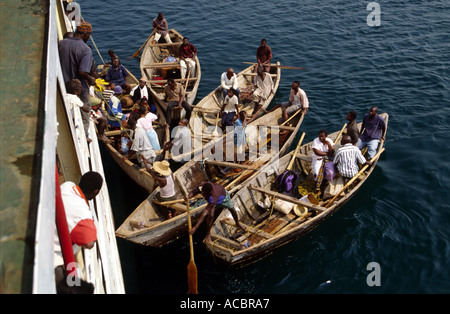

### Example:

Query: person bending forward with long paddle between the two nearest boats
xmin=184 ymin=182 xmax=245 ymax=242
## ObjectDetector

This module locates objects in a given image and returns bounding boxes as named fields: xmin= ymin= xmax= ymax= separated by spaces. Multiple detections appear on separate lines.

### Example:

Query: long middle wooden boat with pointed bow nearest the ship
xmin=116 ymin=108 xmax=304 ymax=246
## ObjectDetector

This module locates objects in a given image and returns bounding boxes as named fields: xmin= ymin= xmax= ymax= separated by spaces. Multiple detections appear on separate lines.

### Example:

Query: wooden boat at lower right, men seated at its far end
xmin=206 ymin=113 xmax=388 ymax=266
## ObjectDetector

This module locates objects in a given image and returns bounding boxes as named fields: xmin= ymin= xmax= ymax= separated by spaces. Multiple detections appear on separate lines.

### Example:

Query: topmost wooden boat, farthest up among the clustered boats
xmin=140 ymin=29 xmax=201 ymax=110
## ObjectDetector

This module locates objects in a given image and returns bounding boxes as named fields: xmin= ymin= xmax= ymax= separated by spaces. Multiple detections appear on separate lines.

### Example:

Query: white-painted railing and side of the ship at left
xmin=33 ymin=0 xmax=125 ymax=294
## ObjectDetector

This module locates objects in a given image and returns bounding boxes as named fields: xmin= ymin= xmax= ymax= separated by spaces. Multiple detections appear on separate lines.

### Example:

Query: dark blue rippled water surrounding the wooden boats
xmin=79 ymin=0 xmax=450 ymax=294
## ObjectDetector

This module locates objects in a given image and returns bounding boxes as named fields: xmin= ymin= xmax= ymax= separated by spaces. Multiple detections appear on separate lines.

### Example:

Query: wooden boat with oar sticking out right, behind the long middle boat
xmin=189 ymin=63 xmax=281 ymax=137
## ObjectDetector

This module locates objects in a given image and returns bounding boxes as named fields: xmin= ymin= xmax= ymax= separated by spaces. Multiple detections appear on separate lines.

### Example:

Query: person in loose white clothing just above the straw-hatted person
xmin=128 ymin=119 xmax=156 ymax=168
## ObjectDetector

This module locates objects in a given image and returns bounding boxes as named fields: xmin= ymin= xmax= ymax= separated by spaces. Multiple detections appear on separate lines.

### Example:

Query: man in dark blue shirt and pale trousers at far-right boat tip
xmin=356 ymin=106 xmax=386 ymax=159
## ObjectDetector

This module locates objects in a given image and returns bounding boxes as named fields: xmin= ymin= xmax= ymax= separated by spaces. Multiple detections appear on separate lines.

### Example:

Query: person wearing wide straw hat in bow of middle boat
xmin=144 ymin=159 xmax=177 ymax=219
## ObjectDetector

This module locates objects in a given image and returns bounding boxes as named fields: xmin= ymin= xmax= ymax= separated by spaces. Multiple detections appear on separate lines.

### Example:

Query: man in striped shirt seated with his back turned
xmin=333 ymin=135 xmax=372 ymax=179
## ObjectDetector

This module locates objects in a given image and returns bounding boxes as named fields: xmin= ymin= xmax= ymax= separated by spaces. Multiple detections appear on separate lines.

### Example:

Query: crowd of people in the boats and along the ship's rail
xmin=55 ymin=9 xmax=386 ymax=289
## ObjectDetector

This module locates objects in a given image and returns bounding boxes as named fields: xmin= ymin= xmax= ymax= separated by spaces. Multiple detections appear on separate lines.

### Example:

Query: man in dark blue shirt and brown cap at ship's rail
xmin=58 ymin=21 xmax=95 ymax=143
